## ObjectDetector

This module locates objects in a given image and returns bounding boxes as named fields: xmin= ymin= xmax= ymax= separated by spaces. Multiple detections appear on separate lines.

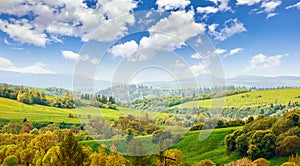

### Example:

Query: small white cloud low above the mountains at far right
xmin=245 ymin=54 xmax=283 ymax=71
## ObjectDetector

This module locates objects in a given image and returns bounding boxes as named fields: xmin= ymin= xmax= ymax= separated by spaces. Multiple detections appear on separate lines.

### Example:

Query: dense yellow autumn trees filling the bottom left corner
xmin=0 ymin=131 xmax=133 ymax=166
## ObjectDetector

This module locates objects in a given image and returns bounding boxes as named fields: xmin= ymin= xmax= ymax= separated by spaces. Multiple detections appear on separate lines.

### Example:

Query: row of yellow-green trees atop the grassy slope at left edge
xmin=0 ymin=86 xmax=75 ymax=108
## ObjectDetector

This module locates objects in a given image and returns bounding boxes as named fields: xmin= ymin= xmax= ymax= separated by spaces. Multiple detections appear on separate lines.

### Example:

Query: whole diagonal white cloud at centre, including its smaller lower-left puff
xmin=110 ymin=10 xmax=205 ymax=61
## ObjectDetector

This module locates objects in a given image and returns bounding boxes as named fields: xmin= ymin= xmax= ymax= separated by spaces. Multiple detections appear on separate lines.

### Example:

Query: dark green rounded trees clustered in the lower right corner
xmin=225 ymin=110 xmax=300 ymax=159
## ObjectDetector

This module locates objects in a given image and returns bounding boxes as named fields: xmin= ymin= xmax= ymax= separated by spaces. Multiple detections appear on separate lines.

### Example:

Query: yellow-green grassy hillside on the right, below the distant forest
xmin=175 ymin=88 xmax=300 ymax=108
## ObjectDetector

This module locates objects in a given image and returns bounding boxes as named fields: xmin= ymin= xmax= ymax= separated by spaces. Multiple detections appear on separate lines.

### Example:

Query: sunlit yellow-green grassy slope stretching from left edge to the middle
xmin=0 ymin=97 xmax=161 ymax=124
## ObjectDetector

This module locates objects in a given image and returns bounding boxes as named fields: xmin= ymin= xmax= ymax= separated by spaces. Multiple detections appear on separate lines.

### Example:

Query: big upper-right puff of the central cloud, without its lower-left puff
xmin=140 ymin=10 xmax=205 ymax=51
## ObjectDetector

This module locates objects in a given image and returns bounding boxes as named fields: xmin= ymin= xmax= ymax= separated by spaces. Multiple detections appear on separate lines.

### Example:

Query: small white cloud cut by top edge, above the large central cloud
xmin=156 ymin=0 xmax=191 ymax=10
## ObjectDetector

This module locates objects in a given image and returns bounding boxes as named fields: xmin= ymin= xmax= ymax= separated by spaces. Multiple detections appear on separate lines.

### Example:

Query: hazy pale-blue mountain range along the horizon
xmin=0 ymin=71 xmax=300 ymax=90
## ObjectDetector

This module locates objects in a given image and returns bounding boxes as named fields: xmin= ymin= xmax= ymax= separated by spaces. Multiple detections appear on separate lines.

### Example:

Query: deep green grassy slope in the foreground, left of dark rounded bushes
xmin=80 ymin=127 xmax=288 ymax=166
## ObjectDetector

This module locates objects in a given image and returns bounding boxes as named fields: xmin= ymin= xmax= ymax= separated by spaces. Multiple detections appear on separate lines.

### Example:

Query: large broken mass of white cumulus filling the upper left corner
xmin=0 ymin=0 xmax=137 ymax=47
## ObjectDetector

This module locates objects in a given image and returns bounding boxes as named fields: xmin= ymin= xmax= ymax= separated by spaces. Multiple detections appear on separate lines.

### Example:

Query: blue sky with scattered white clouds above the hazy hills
xmin=0 ymin=0 xmax=300 ymax=82
